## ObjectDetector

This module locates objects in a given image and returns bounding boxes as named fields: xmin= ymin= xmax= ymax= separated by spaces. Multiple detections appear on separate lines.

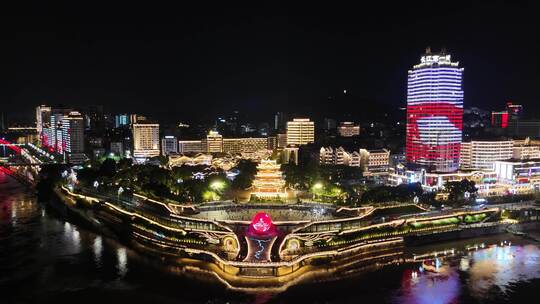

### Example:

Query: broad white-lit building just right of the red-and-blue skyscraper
xmin=460 ymin=140 xmax=514 ymax=170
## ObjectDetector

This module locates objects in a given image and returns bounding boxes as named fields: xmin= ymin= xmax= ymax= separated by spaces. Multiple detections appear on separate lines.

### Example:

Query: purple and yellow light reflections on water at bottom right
xmin=395 ymin=243 xmax=540 ymax=304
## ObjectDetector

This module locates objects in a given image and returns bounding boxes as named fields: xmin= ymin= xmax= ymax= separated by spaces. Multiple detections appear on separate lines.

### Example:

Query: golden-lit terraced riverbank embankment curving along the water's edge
xmin=48 ymin=184 xmax=540 ymax=292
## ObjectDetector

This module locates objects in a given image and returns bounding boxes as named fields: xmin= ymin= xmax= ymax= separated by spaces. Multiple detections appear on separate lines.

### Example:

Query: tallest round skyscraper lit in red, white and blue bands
xmin=406 ymin=48 xmax=463 ymax=172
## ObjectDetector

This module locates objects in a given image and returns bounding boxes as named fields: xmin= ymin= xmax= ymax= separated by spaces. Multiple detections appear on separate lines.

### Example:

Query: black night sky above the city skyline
xmin=7 ymin=1 xmax=540 ymax=121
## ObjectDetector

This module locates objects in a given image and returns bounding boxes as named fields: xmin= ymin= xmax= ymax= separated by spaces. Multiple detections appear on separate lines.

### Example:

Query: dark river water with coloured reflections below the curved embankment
xmin=0 ymin=175 xmax=540 ymax=304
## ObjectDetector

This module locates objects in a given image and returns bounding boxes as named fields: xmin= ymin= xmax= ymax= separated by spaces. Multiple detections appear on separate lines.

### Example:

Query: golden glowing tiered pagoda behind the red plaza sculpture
xmin=251 ymin=160 xmax=287 ymax=199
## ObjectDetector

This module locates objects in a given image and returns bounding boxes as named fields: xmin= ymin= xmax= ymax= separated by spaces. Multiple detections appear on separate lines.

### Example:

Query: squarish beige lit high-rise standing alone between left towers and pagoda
xmin=132 ymin=123 xmax=160 ymax=159
